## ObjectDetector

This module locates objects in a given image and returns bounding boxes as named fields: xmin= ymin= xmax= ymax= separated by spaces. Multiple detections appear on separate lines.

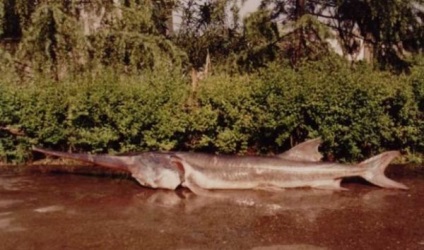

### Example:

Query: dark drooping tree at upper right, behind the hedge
xmin=238 ymin=0 xmax=424 ymax=70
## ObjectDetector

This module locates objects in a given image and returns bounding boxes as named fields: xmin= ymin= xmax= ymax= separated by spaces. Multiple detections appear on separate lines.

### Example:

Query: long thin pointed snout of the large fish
xmin=32 ymin=147 xmax=130 ymax=171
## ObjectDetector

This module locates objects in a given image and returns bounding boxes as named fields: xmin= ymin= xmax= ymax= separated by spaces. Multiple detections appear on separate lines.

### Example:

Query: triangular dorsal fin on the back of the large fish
xmin=277 ymin=138 xmax=323 ymax=162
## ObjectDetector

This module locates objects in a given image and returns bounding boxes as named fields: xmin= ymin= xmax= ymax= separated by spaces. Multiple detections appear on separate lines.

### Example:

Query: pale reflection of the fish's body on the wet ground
xmin=132 ymin=189 xmax=399 ymax=218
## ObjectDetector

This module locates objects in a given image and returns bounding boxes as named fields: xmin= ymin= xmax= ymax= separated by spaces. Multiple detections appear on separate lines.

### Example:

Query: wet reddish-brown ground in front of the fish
xmin=0 ymin=169 xmax=424 ymax=250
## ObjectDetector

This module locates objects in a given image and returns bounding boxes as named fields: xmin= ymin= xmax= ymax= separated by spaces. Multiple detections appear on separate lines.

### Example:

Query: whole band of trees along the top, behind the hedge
xmin=0 ymin=0 xmax=424 ymax=78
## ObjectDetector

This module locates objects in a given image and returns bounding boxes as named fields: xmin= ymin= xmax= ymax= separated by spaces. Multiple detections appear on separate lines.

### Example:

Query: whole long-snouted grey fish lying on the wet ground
xmin=34 ymin=139 xmax=408 ymax=194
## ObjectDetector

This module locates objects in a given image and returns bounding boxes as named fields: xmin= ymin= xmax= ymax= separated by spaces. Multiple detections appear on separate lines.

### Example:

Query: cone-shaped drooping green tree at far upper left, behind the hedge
xmin=17 ymin=3 xmax=88 ymax=79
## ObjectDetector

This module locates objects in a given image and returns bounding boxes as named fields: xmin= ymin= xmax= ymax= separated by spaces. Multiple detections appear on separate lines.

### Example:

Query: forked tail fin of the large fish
xmin=359 ymin=151 xmax=408 ymax=190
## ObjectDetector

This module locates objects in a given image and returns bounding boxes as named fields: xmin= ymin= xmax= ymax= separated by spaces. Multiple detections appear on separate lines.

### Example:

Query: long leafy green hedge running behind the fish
xmin=0 ymin=59 xmax=424 ymax=161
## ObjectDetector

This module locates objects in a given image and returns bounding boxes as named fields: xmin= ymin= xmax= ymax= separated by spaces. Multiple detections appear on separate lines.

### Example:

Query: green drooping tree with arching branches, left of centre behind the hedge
xmin=90 ymin=1 xmax=185 ymax=72
